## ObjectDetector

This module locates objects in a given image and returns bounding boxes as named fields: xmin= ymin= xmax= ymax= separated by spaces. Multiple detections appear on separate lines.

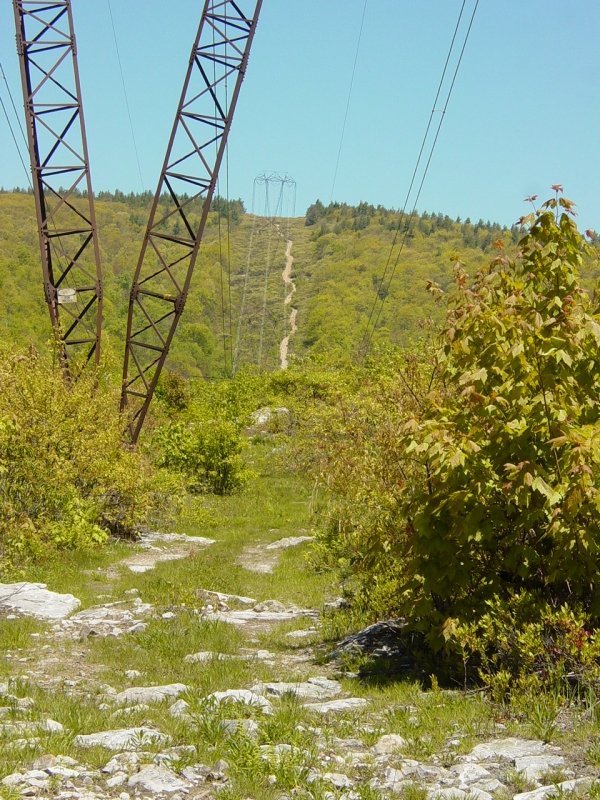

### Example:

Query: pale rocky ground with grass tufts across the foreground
xmin=0 ymin=450 xmax=600 ymax=800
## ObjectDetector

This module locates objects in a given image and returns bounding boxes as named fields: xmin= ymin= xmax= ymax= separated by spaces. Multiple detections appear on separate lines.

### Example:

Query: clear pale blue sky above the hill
xmin=0 ymin=0 xmax=600 ymax=229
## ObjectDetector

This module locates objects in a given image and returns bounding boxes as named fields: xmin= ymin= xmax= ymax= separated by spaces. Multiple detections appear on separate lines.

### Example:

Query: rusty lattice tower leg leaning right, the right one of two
xmin=121 ymin=0 xmax=262 ymax=442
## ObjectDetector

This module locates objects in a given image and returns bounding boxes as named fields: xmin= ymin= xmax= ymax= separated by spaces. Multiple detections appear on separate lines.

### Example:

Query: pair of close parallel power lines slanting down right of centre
xmin=360 ymin=0 xmax=479 ymax=356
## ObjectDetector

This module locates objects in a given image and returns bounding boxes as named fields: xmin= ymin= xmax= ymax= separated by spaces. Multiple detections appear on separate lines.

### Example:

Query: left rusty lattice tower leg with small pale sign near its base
xmin=13 ymin=0 xmax=102 ymax=377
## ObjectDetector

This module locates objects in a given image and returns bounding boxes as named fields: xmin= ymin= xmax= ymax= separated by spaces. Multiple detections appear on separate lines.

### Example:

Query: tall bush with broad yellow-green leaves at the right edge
xmin=403 ymin=198 xmax=600 ymax=643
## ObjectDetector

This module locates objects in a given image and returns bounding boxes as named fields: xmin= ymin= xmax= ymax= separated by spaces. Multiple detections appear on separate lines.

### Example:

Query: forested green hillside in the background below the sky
xmin=0 ymin=192 xmax=556 ymax=377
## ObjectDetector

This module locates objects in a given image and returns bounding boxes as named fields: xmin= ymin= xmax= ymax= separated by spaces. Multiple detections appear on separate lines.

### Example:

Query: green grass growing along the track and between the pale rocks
xmin=0 ymin=440 xmax=600 ymax=800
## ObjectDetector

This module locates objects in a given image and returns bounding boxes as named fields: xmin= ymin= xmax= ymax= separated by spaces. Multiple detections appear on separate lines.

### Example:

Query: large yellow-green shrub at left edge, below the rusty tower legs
xmin=0 ymin=349 xmax=173 ymax=569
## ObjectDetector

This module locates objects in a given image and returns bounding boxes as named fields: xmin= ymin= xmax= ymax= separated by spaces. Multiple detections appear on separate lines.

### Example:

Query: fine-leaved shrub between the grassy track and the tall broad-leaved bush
xmin=296 ymin=348 xmax=432 ymax=618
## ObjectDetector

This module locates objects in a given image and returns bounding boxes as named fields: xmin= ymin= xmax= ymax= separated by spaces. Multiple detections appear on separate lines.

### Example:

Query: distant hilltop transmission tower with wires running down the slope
xmin=233 ymin=172 xmax=296 ymax=373
